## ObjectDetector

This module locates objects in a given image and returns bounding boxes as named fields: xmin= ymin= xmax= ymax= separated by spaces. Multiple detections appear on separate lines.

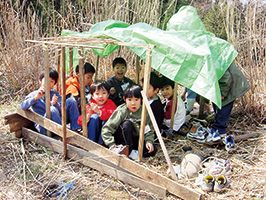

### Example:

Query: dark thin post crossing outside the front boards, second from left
xmin=60 ymin=47 xmax=67 ymax=159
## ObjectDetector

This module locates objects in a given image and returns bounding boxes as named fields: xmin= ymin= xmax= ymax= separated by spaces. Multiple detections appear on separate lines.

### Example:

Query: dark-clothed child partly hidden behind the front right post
xmin=147 ymin=72 xmax=164 ymax=130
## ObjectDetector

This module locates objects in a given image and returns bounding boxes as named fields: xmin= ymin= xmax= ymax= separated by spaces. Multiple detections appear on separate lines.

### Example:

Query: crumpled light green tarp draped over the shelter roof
xmin=62 ymin=6 xmax=238 ymax=107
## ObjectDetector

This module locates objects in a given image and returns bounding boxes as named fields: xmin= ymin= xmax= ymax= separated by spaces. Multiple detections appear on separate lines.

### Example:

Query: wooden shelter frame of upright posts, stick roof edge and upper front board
xmin=4 ymin=35 xmax=203 ymax=199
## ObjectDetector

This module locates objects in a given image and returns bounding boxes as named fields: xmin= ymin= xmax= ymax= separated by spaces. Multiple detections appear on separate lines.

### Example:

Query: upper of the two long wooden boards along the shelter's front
xmin=17 ymin=108 xmax=202 ymax=200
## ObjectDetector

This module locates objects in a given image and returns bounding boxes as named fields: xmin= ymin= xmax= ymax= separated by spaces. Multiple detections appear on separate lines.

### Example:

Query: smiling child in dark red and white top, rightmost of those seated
xmin=161 ymin=76 xmax=186 ymax=135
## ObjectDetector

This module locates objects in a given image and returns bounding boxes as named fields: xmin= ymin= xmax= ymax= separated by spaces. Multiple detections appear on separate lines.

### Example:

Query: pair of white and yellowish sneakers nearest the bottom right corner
xmin=201 ymin=175 xmax=230 ymax=193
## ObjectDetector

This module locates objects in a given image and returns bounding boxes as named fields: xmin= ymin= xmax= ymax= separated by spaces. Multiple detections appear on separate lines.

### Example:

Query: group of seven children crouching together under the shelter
xmin=21 ymin=57 xmax=249 ymax=157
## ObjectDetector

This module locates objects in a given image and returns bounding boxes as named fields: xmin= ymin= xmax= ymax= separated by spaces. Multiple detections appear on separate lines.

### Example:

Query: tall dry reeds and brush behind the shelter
xmin=0 ymin=0 xmax=266 ymax=123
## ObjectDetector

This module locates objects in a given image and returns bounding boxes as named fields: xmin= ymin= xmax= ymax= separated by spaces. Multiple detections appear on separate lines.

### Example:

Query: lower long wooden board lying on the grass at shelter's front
xmin=23 ymin=128 xmax=166 ymax=198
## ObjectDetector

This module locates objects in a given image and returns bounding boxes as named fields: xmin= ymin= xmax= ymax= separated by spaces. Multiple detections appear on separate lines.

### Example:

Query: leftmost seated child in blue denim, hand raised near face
xmin=20 ymin=68 xmax=81 ymax=135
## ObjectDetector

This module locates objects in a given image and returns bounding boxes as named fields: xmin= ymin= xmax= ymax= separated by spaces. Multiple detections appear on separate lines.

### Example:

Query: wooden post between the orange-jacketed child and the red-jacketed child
xmin=79 ymin=57 xmax=88 ymax=138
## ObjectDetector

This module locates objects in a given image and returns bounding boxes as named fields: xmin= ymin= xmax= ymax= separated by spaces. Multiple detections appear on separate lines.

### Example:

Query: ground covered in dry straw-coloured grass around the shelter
xmin=0 ymin=102 xmax=266 ymax=199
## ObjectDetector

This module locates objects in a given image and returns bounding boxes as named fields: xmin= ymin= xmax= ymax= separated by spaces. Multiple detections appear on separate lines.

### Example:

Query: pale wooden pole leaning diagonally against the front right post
xmin=141 ymin=91 xmax=177 ymax=180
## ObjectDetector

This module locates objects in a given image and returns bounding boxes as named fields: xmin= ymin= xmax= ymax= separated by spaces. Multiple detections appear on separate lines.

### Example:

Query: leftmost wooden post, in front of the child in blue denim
xmin=44 ymin=47 xmax=52 ymax=137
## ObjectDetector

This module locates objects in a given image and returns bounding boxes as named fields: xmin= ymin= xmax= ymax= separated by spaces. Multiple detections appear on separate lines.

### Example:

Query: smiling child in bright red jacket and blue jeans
xmin=78 ymin=81 xmax=116 ymax=144
